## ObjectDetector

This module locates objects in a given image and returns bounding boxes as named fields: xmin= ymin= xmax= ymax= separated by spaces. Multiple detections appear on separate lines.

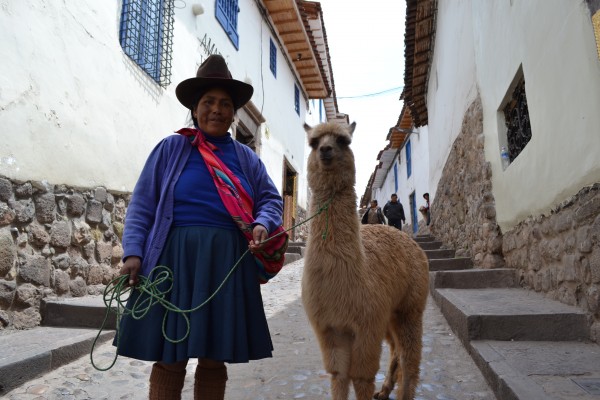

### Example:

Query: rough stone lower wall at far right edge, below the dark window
xmin=502 ymin=183 xmax=600 ymax=341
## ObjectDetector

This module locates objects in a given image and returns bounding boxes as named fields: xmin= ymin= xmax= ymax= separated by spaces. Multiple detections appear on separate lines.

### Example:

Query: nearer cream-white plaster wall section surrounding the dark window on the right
xmin=472 ymin=0 xmax=600 ymax=230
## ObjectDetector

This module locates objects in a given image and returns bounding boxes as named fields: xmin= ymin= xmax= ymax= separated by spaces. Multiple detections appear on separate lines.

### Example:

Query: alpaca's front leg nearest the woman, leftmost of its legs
xmin=319 ymin=329 xmax=352 ymax=400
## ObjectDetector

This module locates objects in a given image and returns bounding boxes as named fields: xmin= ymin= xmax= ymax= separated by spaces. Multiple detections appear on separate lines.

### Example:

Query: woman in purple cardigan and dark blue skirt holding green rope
xmin=115 ymin=55 xmax=287 ymax=400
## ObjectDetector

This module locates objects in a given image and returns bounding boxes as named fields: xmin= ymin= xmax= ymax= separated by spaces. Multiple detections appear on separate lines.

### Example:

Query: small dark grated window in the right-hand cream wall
xmin=504 ymin=78 xmax=531 ymax=162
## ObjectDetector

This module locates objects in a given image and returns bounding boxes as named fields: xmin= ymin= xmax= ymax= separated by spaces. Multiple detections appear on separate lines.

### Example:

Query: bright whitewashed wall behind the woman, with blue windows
xmin=0 ymin=0 xmax=306 ymax=207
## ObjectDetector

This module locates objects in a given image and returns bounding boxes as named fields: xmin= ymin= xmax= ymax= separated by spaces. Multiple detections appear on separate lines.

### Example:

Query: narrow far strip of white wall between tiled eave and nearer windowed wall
xmin=427 ymin=0 xmax=478 ymax=202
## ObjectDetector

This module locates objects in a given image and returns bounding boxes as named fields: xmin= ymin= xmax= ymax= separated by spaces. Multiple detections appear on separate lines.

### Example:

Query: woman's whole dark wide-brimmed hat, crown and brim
xmin=175 ymin=54 xmax=254 ymax=110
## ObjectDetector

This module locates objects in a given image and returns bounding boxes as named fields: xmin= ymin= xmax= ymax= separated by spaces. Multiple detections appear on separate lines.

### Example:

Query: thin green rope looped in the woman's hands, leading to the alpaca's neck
xmin=90 ymin=196 xmax=333 ymax=371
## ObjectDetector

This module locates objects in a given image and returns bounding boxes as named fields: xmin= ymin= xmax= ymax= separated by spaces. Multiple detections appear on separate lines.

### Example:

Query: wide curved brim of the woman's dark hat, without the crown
xmin=175 ymin=78 xmax=254 ymax=110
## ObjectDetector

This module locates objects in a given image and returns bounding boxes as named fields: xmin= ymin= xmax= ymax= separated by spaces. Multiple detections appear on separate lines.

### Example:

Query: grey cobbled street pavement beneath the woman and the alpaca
xmin=5 ymin=260 xmax=495 ymax=400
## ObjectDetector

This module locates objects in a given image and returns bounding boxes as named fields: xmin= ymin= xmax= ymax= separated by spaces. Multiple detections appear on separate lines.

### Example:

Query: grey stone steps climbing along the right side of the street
xmin=416 ymin=236 xmax=600 ymax=400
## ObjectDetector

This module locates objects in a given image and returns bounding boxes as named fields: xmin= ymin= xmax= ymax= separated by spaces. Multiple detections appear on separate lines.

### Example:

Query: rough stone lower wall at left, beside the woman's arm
xmin=0 ymin=177 xmax=129 ymax=329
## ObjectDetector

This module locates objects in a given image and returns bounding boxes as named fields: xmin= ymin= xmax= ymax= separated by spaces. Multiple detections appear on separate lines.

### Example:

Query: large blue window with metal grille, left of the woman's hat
xmin=119 ymin=0 xmax=174 ymax=87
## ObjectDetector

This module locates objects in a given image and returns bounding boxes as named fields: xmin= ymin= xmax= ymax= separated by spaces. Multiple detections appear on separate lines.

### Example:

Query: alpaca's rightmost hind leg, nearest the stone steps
xmin=397 ymin=313 xmax=423 ymax=400
